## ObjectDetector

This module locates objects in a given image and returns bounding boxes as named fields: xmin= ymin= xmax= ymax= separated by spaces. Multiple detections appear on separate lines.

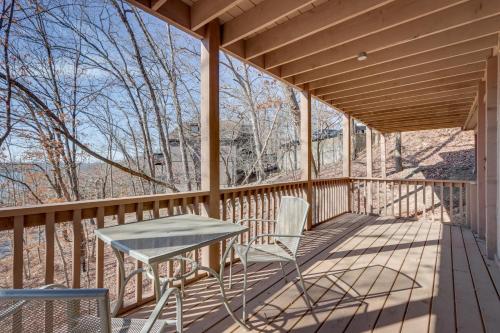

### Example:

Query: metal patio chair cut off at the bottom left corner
xmin=0 ymin=285 xmax=182 ymax=333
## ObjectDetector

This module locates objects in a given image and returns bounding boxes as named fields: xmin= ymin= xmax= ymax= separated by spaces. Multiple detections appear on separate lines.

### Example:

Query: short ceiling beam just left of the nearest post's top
xmin=190 ymin=0 xmax=241 ymax=30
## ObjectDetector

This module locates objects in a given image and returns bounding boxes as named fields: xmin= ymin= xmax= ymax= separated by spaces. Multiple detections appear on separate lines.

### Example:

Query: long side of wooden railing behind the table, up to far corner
xmin=0 ymin=178 xmax=349 ymax=311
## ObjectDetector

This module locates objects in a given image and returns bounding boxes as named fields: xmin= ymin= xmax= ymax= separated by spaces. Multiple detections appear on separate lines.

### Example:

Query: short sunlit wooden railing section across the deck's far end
xmin=351 ymin=178 xmax=476 ymax=226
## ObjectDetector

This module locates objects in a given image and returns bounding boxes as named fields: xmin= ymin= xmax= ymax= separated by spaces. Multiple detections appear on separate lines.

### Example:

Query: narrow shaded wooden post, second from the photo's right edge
xmin=474 ymin=81 xmax=486 ymax=238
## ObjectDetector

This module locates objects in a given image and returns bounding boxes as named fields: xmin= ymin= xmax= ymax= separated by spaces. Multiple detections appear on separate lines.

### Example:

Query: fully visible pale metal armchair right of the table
xmin=229 ymin=197 xmax=311 ymax=322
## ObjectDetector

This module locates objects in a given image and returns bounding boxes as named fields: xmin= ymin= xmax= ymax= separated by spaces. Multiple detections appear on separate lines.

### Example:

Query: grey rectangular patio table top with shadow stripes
xmin=95 ymin=214 xmax=248 ymax=264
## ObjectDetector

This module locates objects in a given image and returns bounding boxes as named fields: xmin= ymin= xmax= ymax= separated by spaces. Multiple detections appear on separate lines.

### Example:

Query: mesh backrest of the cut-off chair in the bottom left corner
xmin=0 ymin=289 xmax=111 ymax=333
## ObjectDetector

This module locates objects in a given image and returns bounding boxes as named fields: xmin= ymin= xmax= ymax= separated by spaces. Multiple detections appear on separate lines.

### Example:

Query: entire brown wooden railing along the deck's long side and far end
xmin=0 ymin=178 xmax=476 ymax=311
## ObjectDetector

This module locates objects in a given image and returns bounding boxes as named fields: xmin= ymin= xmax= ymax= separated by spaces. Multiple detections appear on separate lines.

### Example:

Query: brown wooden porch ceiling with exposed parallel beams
xmin=128 ymin=0 xmax=500 ymax=132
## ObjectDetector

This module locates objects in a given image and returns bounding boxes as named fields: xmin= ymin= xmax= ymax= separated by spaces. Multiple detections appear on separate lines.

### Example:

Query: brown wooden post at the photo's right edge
xmin=486 ymin=56 xmax=498 ymax=259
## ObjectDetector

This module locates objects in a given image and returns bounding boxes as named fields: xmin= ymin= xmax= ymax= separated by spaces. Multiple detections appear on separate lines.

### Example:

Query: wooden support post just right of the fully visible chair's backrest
xmin=300 ymin=86 xmax=312 ymax=230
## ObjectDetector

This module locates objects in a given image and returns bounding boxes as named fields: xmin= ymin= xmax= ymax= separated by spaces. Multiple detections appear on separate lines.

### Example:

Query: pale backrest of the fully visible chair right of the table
xmin=276 ymin=197 xmax=309 ymax=255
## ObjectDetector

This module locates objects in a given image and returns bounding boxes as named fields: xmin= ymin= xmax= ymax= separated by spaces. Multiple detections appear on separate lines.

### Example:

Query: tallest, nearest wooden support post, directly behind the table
xmin=200 ymin=20 xmax=220 ymax=271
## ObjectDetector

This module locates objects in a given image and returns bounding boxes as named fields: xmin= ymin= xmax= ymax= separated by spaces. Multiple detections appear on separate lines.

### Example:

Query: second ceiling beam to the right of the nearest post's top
xmin=245 ymin=0 xmax=394 ymax=59
